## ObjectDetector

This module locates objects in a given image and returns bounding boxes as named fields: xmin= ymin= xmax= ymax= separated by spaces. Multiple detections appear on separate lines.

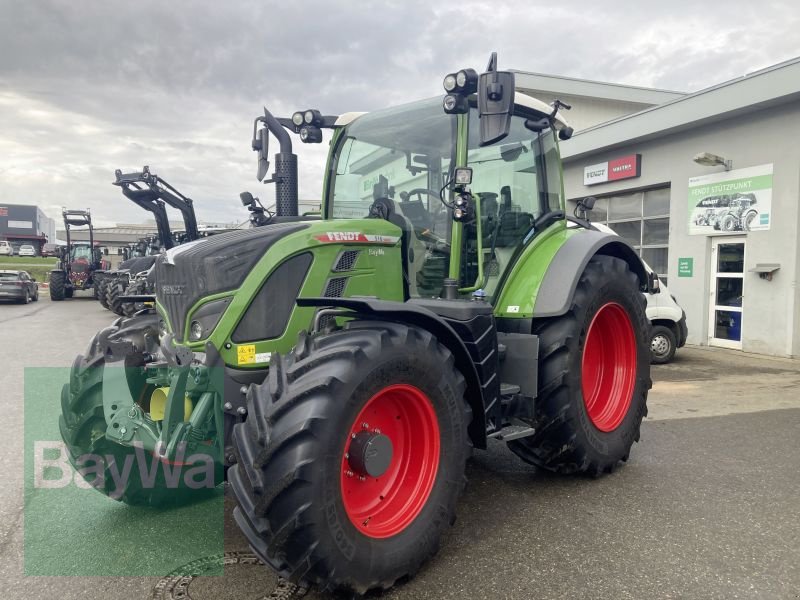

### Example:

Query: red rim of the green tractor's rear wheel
xmin=581 ymin=302 xmax=637 ymax=432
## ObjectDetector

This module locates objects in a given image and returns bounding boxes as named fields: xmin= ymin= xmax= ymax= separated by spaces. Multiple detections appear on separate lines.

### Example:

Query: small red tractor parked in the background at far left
xmin=50 ymin=209 xmax=108 ymax=300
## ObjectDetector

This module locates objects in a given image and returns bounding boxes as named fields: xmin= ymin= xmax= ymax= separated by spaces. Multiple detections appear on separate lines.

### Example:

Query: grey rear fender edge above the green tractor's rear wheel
xmin=533 ymin=229 xmax=650 ymax=318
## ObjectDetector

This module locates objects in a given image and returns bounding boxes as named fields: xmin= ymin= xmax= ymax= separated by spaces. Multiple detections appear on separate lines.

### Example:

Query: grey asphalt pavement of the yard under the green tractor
xmin=0 ymin=295 xmax=800 ymax=600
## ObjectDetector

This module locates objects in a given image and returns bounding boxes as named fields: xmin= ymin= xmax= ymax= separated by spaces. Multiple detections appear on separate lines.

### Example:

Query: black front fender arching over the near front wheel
xmin=297 ymin=298 xmax=490 ymax=449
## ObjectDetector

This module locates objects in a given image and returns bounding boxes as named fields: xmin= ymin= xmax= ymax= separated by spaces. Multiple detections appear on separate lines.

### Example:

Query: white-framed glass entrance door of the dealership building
xmin=708 ymin=237 xmax=745 ymax=350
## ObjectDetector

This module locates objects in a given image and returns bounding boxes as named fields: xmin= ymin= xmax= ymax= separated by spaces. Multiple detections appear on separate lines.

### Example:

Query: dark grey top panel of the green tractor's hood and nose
xmin=155 ymin=222 xmax=308 ymax=341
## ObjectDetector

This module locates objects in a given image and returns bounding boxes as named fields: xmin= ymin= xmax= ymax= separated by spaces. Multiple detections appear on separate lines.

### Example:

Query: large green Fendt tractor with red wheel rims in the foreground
xmin=60 ymin=55 xmax=654 ymax=593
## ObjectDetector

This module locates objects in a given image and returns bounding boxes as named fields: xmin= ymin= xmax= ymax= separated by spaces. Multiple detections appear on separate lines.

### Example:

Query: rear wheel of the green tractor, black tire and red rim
xmin=508 ymin=256 xmax=652 ymax=477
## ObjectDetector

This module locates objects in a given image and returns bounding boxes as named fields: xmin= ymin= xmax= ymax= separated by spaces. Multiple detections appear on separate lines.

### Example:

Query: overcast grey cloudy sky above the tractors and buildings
xmin=0 ymin=0 xmax=800 ymax=224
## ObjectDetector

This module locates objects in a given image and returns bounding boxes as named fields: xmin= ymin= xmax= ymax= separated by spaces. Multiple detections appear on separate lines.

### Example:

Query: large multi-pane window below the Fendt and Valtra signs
xmin=576 ymin=187 xmax=669 ymax=284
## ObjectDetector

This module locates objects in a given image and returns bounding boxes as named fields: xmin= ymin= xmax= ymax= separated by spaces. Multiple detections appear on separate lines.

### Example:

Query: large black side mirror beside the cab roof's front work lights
xmin=478 ymin=52 xmax=515 ymax=146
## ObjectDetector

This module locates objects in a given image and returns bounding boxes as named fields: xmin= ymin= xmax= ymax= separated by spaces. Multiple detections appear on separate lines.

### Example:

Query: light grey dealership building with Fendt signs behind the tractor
xmin=517 ymin=58 xmax=800 ymax=356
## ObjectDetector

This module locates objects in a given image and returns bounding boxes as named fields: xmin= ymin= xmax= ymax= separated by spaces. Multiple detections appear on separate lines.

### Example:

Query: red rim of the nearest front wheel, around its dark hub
xmin=341 ymin=384 xmax=440 ymax=538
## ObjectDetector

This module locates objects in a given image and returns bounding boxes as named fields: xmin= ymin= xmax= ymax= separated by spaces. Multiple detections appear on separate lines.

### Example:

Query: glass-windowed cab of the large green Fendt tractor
xmin=324 ymin=94 xmax=565 ymax=297
